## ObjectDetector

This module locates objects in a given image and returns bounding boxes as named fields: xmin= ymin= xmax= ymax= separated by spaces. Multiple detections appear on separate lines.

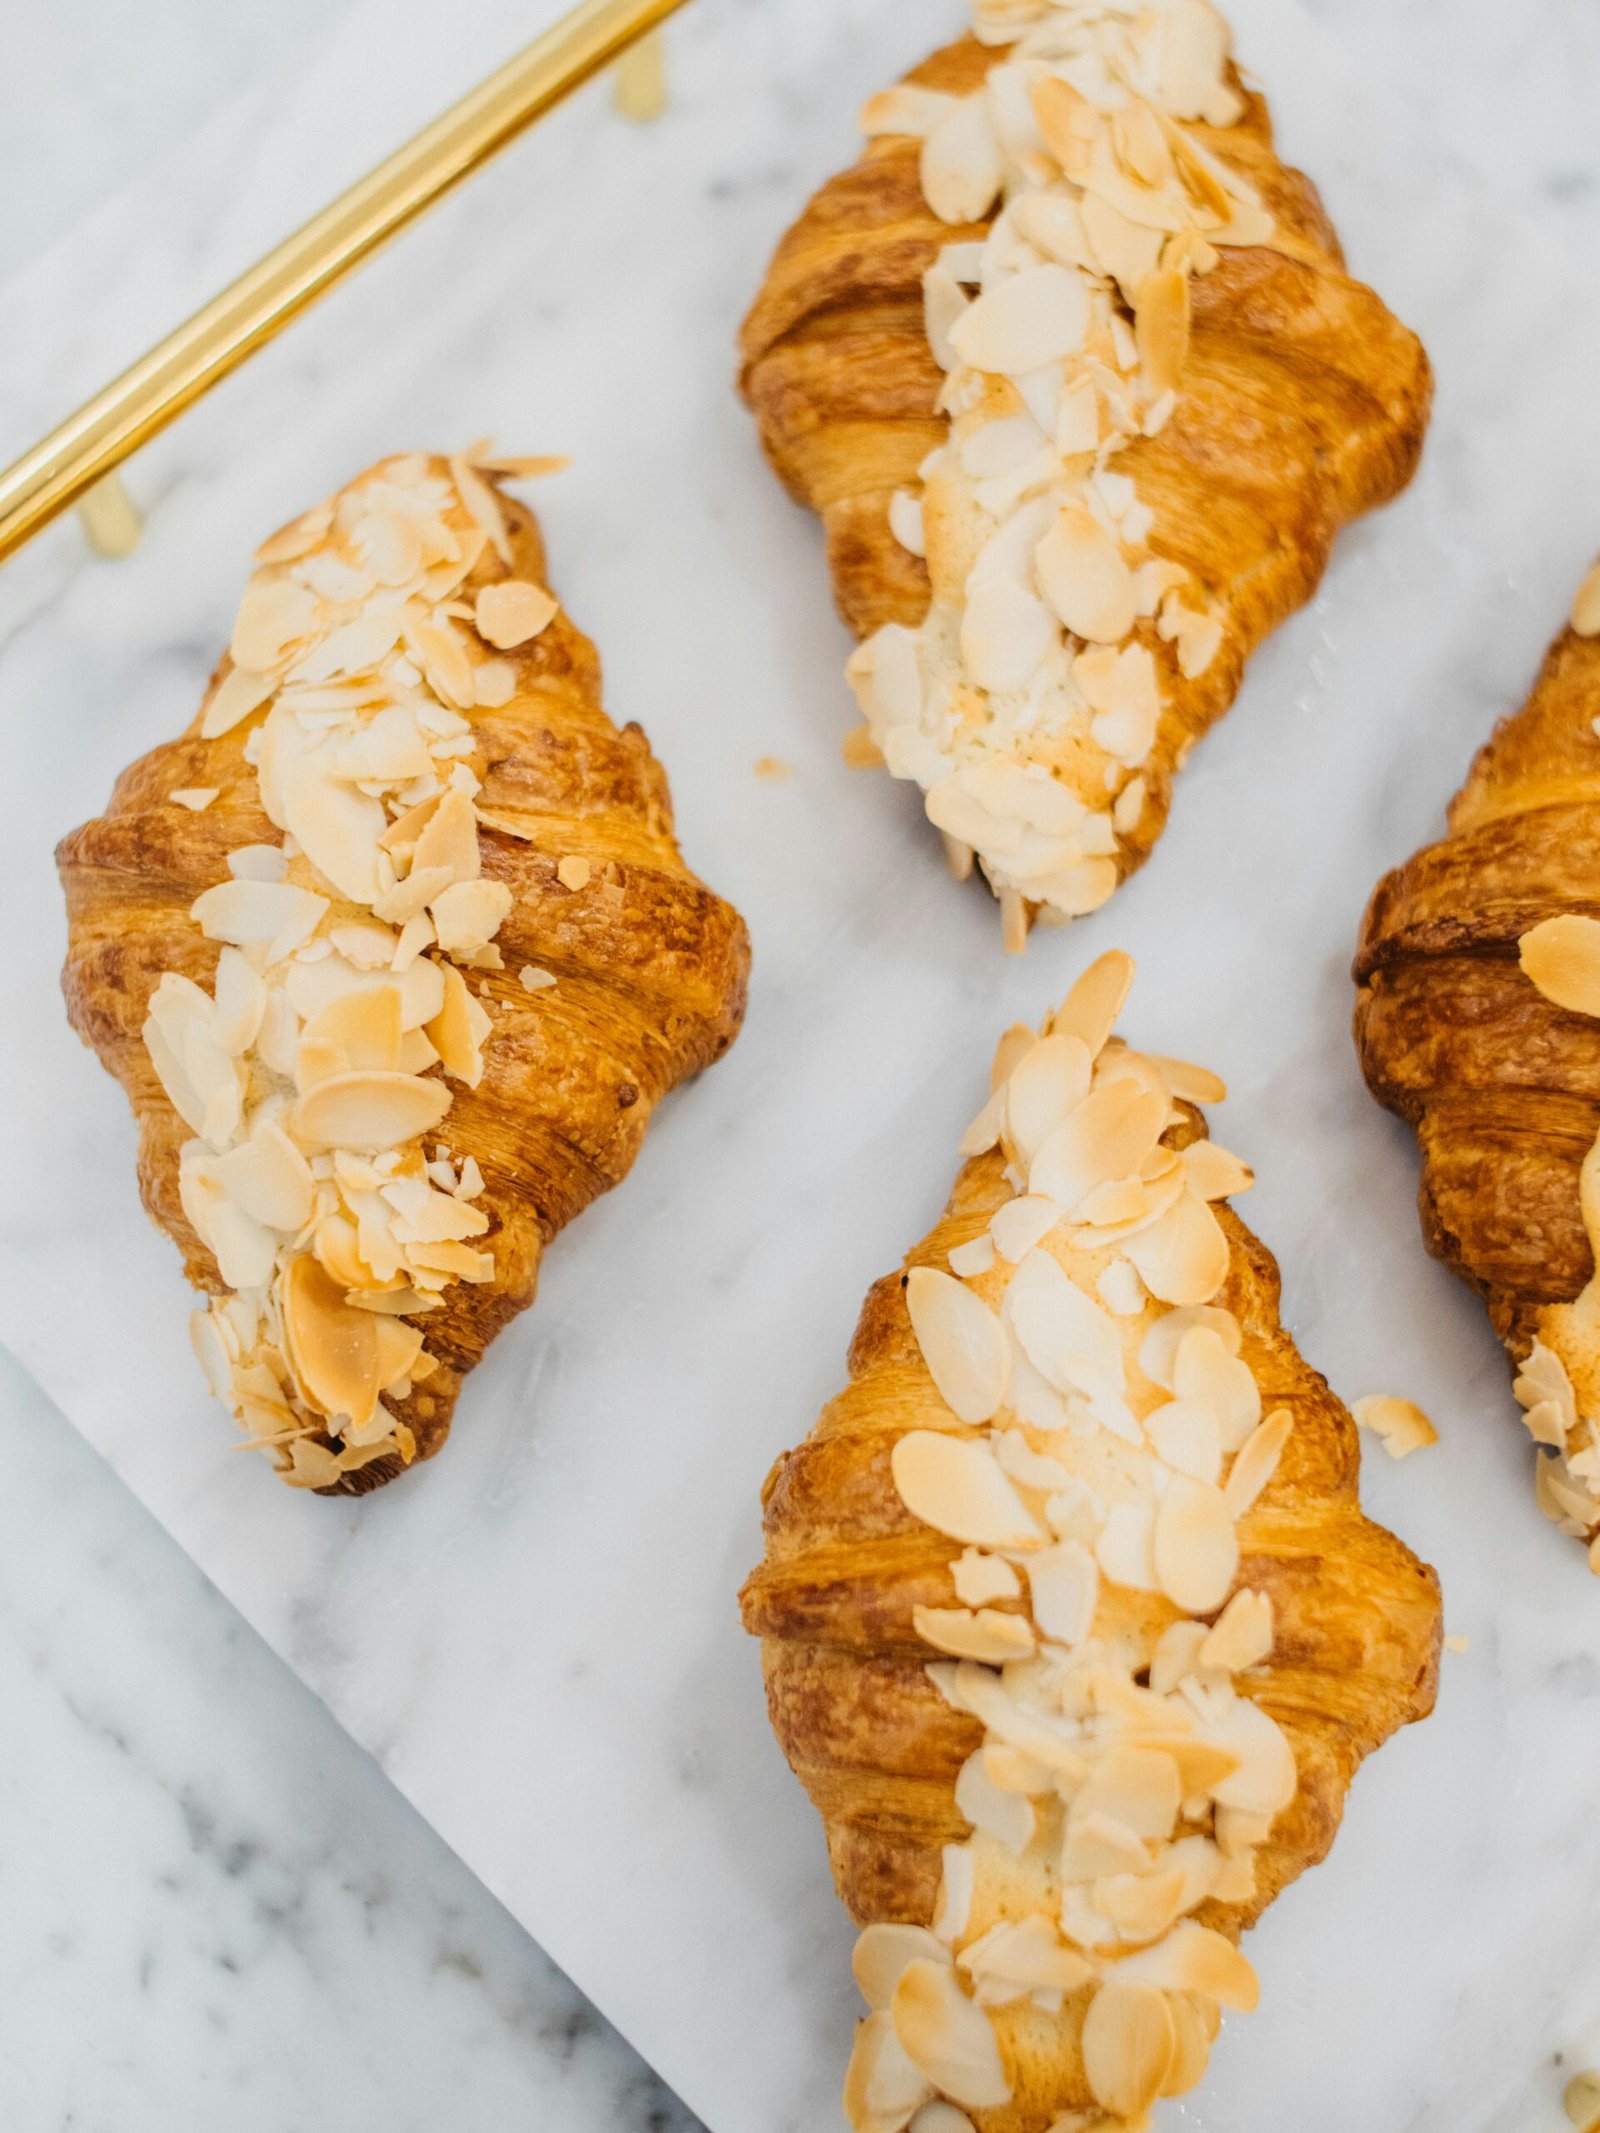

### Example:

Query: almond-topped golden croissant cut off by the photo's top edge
xmin=742 ymin=0 xmax=1431 ymax=949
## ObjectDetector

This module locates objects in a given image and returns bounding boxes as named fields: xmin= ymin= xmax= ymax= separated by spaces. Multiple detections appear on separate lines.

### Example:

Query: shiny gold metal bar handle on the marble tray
xmin=0 ymin=0 xmax=685 ymax=559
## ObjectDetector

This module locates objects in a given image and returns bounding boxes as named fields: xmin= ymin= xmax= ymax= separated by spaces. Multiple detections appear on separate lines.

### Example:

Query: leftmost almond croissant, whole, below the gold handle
xmin=58 ymin=456 xmax=749 ymax=1493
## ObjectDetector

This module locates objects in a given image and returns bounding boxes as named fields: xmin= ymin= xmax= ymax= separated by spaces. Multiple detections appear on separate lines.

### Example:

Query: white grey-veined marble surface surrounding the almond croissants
xmin=0 ymin=0 xmax=1600 ymax=2133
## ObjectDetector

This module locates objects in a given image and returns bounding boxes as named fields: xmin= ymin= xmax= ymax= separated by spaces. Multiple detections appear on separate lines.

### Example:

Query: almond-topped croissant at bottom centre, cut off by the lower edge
xmin=742 ymin=953 xmax=1440 ymax=2133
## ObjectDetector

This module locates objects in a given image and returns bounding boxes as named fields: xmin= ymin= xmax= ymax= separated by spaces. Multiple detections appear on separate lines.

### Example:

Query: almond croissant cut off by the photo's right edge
xmin=1355 ymin=565 xmax=1600 ymax=1572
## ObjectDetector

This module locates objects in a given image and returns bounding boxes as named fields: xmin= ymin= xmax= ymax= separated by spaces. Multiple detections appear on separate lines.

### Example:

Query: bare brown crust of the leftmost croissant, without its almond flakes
xmin=58 ymin=459 xmax=749 ymax=1493
